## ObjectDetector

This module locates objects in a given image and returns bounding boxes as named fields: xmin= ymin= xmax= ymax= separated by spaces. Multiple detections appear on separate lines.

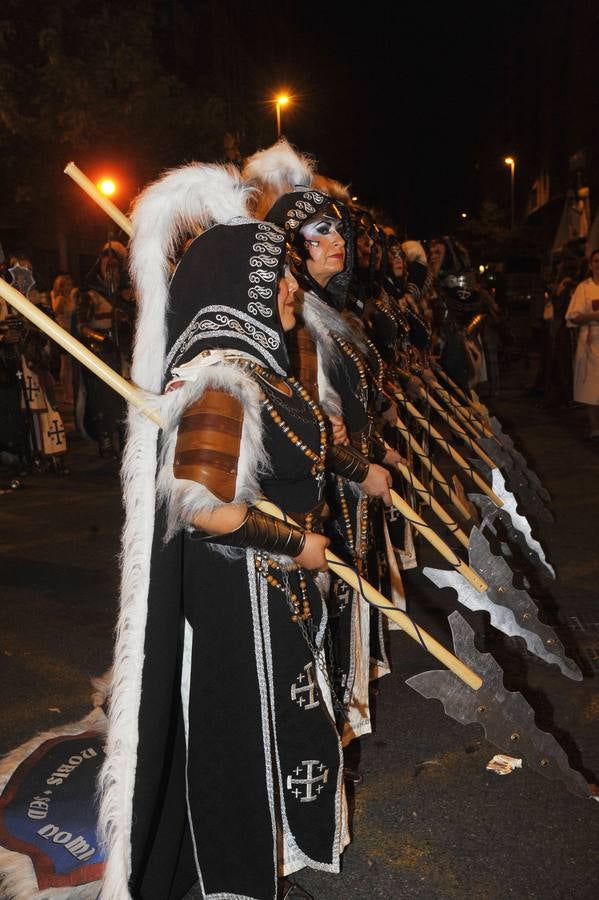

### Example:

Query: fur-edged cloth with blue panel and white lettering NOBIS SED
xmin=0 ymin=707 xmax=106 ymax=900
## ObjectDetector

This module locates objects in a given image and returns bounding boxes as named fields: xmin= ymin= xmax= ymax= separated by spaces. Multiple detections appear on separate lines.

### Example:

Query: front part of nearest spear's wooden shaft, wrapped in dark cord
xmin=256 ymin=500 xmax=483 ymax=691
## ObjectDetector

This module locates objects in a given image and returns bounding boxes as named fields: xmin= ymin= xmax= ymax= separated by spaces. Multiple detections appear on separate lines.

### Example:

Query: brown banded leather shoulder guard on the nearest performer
xmin=173 ymin=390 xmax=243 ymax=503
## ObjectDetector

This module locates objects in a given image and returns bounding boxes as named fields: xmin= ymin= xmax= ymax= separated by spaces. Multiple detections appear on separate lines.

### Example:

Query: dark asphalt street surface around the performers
xmin=0 ymin=356 xmax=599 ymax=900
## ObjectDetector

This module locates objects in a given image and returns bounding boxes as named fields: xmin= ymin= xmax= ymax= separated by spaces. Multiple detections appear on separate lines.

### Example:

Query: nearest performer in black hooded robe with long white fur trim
xmin=101 ymin=165 xmax=366 ymax=900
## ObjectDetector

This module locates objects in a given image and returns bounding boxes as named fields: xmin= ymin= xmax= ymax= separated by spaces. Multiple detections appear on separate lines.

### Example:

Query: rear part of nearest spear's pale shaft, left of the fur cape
xmin=0 ymin=278 xmax=160 ymax=425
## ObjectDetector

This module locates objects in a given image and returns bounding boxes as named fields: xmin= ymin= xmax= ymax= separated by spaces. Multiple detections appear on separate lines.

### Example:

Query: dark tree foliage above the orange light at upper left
xmin=0 ymin=0 xmax=228 ymax=218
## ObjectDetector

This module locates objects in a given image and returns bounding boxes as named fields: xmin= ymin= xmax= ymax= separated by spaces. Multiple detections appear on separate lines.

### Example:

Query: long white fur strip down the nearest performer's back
xmin=99 ymin=163 xmax=262 ymax=900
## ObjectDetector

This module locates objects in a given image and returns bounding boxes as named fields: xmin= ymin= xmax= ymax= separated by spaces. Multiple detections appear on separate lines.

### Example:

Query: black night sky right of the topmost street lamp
xmin=239 ymin=2 xmax=540 ymax=236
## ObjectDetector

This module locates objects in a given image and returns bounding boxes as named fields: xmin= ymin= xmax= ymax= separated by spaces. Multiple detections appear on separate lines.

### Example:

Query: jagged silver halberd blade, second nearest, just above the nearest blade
xmin=423 ymin=528 xmax=582 ymax=681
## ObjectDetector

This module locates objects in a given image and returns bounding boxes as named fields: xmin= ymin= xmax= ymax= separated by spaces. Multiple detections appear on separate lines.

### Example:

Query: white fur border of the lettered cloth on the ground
xmin=0 ymin=707 xmax=107 ymax=900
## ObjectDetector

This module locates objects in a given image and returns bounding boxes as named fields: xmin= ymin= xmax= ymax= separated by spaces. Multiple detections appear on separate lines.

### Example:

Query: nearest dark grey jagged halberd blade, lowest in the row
xmin=406 ymin=612 xmax=591 ymax=798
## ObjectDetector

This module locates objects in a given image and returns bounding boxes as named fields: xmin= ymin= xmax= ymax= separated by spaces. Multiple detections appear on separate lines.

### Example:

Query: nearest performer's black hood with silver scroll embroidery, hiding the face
xmin=166 ymin=220 xmax=289 ymax=380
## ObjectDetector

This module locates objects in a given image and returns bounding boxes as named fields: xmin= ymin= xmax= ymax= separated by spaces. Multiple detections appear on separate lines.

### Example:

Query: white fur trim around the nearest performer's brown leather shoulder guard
xmin=156 ymin=365 xmax=270 ymax=541
